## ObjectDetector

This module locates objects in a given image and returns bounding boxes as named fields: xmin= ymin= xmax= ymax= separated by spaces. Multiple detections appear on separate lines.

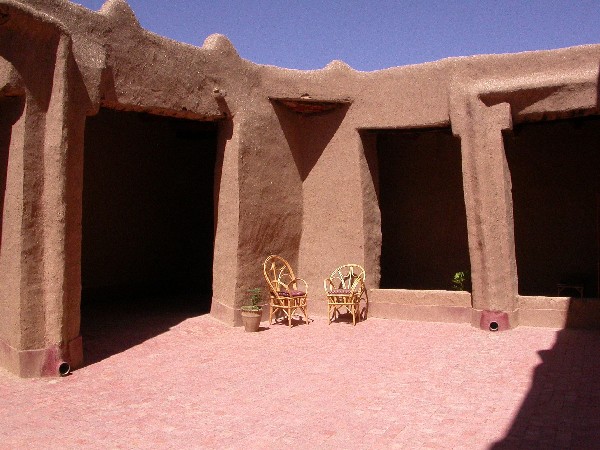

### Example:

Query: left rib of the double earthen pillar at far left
xmin=0 ymin=90 xmax=45 ymax=376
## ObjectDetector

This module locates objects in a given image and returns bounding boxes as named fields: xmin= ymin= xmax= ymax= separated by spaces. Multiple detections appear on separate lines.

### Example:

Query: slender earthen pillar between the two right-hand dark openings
xmin=451 ymin=92 xmax=518 ymax=330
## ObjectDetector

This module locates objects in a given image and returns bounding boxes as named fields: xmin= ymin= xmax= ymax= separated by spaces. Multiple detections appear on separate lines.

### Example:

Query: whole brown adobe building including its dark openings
xmin=0 ymin=0 xmax=600 ymax=377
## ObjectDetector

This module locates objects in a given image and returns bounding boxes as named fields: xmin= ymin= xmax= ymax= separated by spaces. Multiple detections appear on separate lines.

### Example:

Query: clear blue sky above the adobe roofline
xmin=75 ymin=0 xmax=600 ymax=70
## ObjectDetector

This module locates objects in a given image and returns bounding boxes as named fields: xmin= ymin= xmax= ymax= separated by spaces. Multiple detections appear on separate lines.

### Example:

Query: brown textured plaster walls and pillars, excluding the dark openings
xmin=0 ymin=0 xmax=600 ymax=372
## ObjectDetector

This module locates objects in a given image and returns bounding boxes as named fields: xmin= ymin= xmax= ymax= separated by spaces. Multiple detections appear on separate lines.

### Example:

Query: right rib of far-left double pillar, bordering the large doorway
xmin=42 ymin=35 xmax=88 ymax=375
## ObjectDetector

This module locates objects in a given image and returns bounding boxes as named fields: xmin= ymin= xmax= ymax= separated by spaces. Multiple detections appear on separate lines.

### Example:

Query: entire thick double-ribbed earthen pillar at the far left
xmin=0 ymin=9 xmax=89 ymax=377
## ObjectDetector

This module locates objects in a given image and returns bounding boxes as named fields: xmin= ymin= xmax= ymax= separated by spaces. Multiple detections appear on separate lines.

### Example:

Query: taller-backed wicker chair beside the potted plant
xmin=263 ymin=255 xmax=308 ymax=327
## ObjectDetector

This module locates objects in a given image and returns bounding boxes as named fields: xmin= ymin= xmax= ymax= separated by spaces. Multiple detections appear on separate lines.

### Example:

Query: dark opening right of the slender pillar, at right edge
xmin=504 ymin=117 xmax=600 ymax=297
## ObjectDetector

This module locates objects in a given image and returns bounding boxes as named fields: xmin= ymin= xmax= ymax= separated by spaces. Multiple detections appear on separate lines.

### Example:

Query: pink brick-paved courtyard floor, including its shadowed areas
xmin=0 ymin=315 xmax=600 ymax=450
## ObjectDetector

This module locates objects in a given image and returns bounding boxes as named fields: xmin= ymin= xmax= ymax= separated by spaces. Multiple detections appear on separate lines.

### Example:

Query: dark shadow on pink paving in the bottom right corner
xmin=492 ymin=329 xmax=600 ymax=450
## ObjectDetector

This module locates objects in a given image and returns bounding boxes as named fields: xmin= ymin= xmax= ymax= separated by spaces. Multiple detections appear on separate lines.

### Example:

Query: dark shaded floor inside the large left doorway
xmin=81 ymin=293 xmax=211 ymax=366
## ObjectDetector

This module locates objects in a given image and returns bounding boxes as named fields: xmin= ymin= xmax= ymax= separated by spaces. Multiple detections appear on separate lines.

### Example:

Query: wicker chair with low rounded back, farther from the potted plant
xmin=323 ymin=264 xmax=369 ymax=325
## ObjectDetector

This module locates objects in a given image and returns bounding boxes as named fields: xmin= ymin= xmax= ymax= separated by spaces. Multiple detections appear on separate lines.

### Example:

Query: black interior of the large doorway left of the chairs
xmin=81 ymin=109 xmax=217 ymax=360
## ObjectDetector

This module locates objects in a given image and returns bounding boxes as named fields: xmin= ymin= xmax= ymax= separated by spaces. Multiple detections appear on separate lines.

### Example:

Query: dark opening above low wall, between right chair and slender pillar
xmin=377 ymin=129 xmax=470 ymax=290
